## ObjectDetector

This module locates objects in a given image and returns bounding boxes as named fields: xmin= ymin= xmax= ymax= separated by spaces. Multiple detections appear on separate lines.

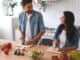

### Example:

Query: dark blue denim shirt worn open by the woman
xmin=54 ymin=26 xmax=79 ymax=48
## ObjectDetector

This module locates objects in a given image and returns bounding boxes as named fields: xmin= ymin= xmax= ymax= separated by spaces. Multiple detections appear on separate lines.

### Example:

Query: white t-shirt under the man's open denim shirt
xmin=25 ymin=14 xmax=32 ymax=41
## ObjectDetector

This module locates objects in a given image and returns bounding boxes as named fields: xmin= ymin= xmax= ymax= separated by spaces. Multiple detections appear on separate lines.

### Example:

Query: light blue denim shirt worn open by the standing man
xmin=18 ymin=11 xmax=45 ymax=38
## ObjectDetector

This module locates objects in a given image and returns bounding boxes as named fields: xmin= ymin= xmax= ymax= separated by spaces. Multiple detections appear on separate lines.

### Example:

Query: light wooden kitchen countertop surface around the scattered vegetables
xmin=0 ymin=39 xmax=79 ymax=60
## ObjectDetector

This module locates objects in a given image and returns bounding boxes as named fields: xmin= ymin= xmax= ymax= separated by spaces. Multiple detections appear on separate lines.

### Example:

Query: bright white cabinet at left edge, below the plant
xmin=0 ymin=16 xmax=13 ymax=40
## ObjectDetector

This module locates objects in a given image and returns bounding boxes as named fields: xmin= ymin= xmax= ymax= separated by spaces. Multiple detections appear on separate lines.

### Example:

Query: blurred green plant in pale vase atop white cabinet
xmin=2 ymin=0 xmax=17 ymax=16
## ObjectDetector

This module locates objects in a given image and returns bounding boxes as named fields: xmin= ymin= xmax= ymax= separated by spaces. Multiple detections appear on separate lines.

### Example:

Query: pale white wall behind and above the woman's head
xmin=43 ymin=0 xmax=80 ymax=27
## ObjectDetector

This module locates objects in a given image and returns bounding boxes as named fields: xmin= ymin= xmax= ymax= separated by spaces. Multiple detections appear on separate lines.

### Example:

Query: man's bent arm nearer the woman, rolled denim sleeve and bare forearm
xmin=32 ymin=14 xmax=45 ymax=42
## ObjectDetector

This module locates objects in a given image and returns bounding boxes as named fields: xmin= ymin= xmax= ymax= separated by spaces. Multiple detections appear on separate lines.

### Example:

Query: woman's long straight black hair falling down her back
xmin=62 ymin=11 xmax=76 ymax=44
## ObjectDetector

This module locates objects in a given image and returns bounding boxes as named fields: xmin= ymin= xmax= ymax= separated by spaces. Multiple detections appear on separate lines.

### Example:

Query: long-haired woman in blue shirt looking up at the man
xmin=53 ymin=11 xmax=79 ymax=49
